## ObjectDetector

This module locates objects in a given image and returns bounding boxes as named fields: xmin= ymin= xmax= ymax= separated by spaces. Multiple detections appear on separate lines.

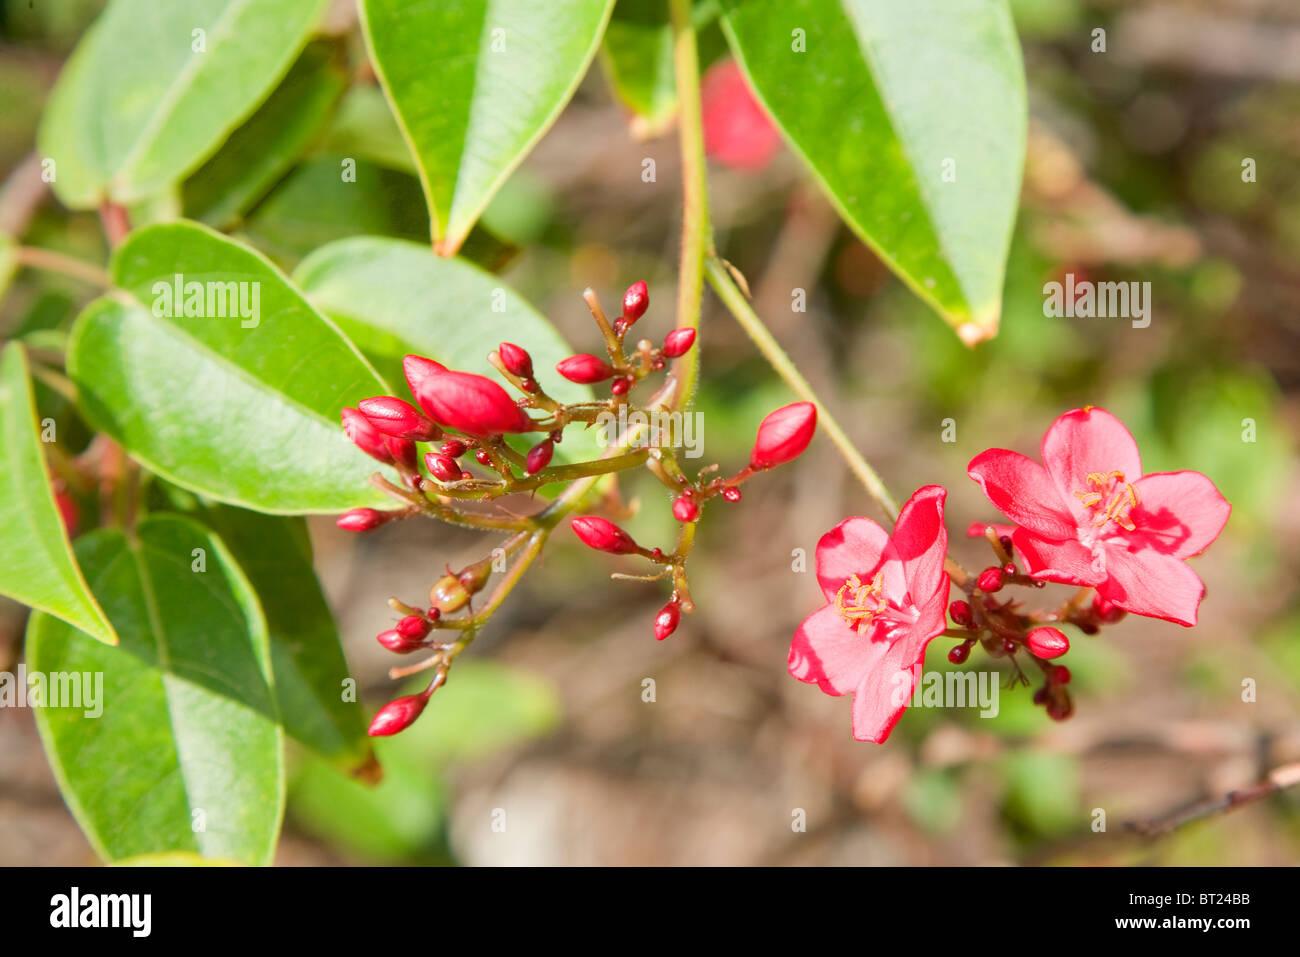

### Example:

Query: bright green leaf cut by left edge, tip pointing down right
xmin=0 ymin=342 xmax=117 ymax=645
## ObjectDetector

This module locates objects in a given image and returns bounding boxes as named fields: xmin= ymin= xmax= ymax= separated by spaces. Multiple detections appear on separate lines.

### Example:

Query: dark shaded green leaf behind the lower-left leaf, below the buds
xmin=200 ymin=506 xmax=372 ymax=771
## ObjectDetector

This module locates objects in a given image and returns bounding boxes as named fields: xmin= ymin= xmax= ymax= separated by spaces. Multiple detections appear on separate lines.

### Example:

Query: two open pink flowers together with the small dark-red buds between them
xmin=789 ymin=407 xmax=1231 ymax=742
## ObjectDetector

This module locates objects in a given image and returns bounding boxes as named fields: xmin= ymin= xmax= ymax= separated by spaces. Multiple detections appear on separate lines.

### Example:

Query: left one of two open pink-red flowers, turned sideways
xmin=789 ymin=485 xmax=949 ymax=744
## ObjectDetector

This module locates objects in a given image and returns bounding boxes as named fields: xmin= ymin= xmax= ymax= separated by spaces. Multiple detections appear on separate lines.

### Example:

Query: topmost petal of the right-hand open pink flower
xmin=1040 ymin=407 xmax=1141 ymax=524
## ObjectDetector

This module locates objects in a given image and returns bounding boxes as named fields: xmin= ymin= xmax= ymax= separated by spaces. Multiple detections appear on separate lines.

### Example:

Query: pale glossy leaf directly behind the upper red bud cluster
xmin=294 ymin=237 xmax=594 ymax=402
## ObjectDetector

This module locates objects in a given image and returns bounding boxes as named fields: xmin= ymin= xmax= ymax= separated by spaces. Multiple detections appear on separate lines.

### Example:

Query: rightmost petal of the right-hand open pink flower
xmin=1127 ymin=472 xmax=1232 ymax=558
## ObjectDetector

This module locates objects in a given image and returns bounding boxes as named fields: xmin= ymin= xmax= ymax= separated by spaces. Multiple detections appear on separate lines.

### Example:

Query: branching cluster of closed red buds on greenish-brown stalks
xmin=337 ymin=281 xmax=816 ymax=736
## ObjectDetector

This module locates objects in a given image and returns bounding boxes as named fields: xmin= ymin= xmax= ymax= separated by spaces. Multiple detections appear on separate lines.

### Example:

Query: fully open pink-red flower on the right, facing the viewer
xmin=967 ymin=406 xmax=1232 ymax=627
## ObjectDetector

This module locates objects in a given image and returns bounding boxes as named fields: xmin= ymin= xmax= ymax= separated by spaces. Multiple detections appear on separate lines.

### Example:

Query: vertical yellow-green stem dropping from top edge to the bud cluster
xmin=670 ymin=0 xmax=710 ymax=408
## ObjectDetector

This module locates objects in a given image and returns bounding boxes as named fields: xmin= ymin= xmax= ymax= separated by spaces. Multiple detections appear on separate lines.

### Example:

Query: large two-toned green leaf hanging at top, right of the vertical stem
xmin=722 ymin=0 xmax=1027 ymax=345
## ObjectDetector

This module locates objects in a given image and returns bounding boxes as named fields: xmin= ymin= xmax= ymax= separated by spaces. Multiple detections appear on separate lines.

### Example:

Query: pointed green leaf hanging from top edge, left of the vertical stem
xmin=360 ymin=0 xmax=614 ymax=256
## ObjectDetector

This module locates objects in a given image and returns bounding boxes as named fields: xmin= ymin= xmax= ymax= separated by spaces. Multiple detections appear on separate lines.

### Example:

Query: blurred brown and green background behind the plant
xmin=0 ymin=0 xmax=1300 ymax=865
